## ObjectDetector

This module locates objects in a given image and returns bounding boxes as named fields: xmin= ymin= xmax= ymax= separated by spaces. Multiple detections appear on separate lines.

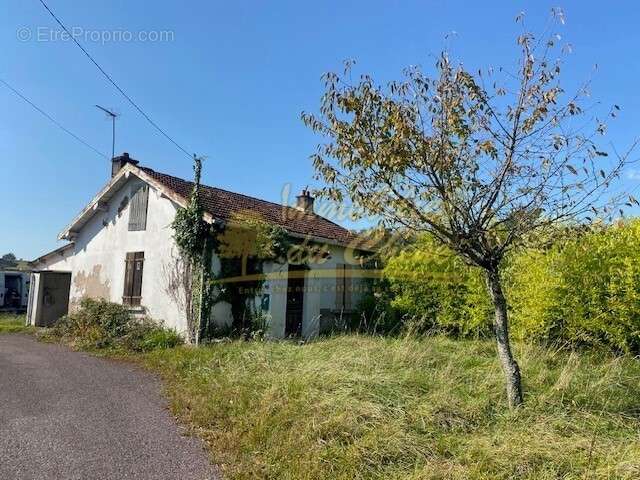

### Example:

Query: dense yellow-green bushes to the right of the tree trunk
xmin=508 ymin=221 xmax=640 ymax=353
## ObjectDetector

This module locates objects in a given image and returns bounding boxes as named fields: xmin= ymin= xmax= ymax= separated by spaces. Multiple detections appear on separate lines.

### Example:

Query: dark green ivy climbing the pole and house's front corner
xmin=172 ymin=156 xmax=291 ymax=344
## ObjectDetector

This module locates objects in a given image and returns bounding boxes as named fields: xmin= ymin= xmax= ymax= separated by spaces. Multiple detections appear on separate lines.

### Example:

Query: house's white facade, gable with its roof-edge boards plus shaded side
xmin=35 ymin=159 xmax=361 ymax=338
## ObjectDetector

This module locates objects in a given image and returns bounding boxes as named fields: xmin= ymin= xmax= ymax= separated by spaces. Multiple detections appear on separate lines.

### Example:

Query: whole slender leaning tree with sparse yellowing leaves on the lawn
xmin=302 ymin=10 xmax=637 ymax=407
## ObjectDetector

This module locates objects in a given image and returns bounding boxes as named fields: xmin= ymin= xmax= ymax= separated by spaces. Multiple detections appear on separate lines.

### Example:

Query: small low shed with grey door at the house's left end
xmin=27 ymin=270 xmax=71 ymax=327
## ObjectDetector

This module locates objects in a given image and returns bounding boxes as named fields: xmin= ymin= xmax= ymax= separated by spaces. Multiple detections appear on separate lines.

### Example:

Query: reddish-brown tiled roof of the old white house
xmin=138 ymin=167 xmax=355 ymax=245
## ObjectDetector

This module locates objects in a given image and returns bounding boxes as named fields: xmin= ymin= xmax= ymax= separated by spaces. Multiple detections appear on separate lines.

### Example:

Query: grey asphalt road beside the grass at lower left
xmin=0 ymin=334 xmax=216 ymax=480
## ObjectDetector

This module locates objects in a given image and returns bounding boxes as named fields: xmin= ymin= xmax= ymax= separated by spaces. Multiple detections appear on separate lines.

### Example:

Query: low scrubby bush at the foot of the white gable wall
xmin=51 ymin=298 xmax=182 ymax=352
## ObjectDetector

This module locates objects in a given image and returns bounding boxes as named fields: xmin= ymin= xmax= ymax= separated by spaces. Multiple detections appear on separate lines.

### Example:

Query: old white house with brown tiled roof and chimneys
xmin=34 ymin=153 xmax=370 ymax=338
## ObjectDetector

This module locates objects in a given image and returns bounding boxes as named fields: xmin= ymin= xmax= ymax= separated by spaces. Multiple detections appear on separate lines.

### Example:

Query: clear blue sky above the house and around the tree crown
xmin=0 ymin=0 xmax=640 ymax=258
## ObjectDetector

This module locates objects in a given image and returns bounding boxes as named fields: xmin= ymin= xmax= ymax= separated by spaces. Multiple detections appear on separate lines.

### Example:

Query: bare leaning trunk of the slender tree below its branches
xmin=485 ymin=268 xmax=523 ymax=408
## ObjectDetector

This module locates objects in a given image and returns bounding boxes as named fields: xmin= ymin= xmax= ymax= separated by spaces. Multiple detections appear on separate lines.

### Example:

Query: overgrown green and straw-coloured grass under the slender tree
xmin=143 ymin=336 xmax=640 ymax=480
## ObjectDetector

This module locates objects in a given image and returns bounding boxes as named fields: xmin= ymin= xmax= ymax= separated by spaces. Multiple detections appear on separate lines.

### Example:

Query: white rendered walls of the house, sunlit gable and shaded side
xmin=37 ymin=175 xmax=359 ymax=338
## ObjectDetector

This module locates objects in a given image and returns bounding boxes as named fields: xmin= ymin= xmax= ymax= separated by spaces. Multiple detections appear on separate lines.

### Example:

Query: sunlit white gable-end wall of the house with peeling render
xmin=41 ymin=175 xmax=186 ymax=332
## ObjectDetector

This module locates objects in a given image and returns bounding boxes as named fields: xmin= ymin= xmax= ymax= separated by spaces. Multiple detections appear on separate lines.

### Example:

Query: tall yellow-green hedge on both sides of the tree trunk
xmin=376 ymin=221 xmax=640 ymax=353
